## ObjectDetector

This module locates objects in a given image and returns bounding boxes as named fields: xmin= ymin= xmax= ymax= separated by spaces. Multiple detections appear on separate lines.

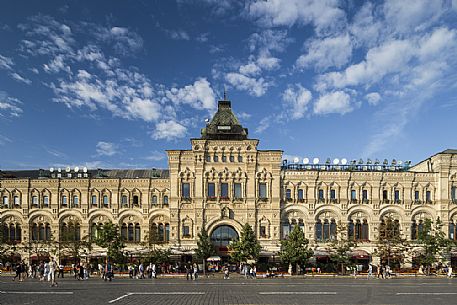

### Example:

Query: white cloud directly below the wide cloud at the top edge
xmin=296 ymin=34 xmax=352 ymax=70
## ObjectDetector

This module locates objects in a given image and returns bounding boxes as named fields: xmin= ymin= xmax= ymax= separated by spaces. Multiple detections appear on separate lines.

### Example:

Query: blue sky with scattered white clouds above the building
xmin=0 ymin=0 xmax=457 ymax=169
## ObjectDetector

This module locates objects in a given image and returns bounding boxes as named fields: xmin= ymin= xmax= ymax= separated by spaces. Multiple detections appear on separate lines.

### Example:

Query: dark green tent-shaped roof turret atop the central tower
xmin=201 ymin=100 xmax=248 ymax=140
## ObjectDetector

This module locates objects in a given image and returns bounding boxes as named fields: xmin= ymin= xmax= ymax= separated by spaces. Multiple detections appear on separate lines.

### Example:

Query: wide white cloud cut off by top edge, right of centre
xmin=246 ymin=0 xmax=345 ymax=33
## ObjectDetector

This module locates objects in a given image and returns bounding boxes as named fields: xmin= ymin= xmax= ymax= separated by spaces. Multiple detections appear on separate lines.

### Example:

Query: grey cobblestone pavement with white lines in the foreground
xmin=0 ymin=276 xmax=457 ymax=305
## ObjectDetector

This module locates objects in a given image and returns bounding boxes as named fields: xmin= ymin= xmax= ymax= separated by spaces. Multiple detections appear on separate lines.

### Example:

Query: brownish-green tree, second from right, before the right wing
xmin=374 ymin=217 xmax=409 ymax=270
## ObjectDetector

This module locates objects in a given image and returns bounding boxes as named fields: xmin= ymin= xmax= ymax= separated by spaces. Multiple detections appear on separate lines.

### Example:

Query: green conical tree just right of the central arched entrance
xmin=229 ymin=223 xmax=262 ymax=263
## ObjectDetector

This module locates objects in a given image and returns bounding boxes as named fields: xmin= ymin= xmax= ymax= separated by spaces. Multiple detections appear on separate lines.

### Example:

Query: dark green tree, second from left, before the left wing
xmin=95 ymin=222 xmax=125 ymax=262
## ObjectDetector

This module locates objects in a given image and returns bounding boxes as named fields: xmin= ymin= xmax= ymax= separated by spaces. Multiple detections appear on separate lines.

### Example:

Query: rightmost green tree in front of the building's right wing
xmin=417 ymin=217 xmax=453 ymax=275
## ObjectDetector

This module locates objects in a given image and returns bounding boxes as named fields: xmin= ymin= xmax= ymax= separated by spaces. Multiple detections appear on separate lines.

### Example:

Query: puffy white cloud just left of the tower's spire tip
xmin=166 ymin=78 xmax=216 ymax=110
